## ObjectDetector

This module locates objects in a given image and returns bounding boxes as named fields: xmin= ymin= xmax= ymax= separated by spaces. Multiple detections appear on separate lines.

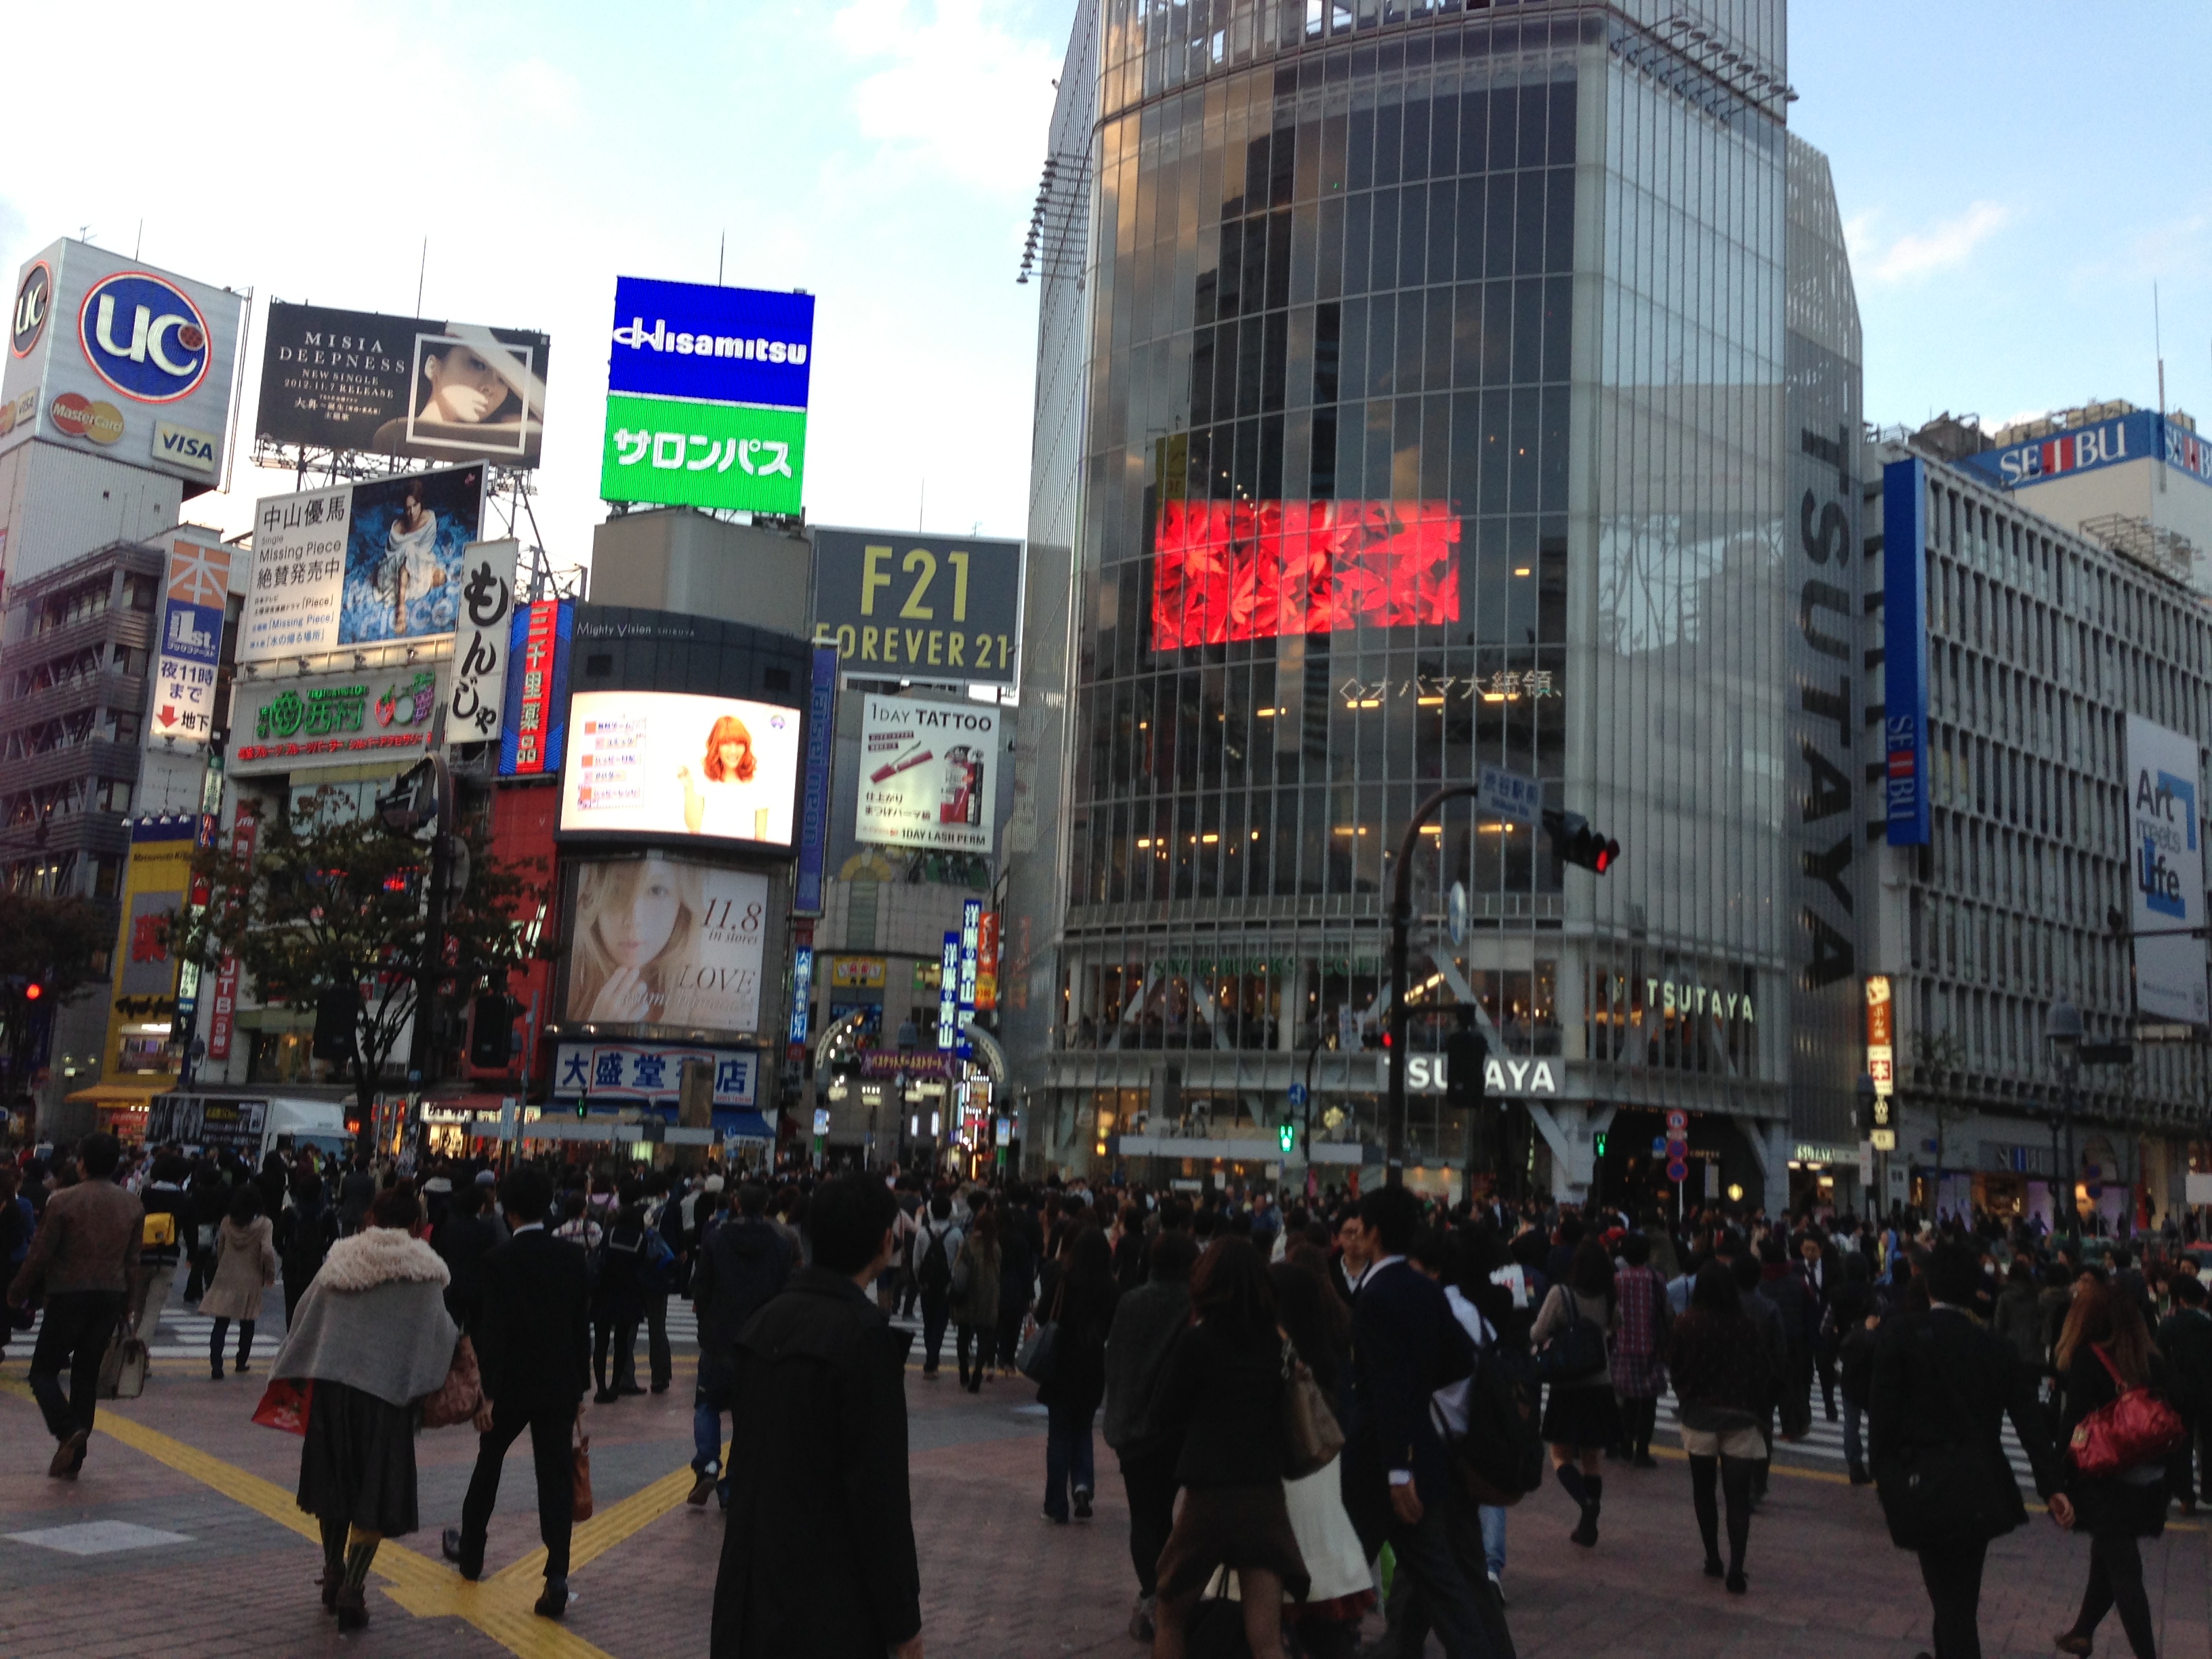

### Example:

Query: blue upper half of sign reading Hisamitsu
xmin=606 ymin=276 xmax=814 ymax=409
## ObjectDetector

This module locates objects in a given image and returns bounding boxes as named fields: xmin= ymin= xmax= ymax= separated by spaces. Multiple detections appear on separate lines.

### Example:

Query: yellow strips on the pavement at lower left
xmin=0 ymin=1380 xmax=693 ymax=1659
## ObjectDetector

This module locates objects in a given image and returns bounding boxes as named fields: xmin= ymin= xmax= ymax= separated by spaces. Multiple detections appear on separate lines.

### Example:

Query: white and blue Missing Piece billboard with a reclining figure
xmin=239 ymin=467 xmax=485 ymax=663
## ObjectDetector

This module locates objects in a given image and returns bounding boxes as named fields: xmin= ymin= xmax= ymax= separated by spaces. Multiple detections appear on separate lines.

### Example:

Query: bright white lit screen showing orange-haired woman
xmin=560 ymin=690 xmax=803 ymax=847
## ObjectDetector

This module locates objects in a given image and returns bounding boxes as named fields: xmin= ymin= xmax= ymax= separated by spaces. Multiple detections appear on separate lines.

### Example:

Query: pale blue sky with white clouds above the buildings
xmin=0 ymin=0 xmax=2212 ymax=562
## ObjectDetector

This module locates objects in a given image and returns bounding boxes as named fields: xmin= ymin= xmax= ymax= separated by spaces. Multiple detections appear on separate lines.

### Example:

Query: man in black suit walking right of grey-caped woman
xmin=445 ymin=1168 xmax=590 ymax=1619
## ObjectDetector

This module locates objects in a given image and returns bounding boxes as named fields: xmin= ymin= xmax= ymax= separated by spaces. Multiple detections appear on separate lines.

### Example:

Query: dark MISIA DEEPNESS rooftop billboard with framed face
xmin=254 ymin=301 xmax=548 ymax=467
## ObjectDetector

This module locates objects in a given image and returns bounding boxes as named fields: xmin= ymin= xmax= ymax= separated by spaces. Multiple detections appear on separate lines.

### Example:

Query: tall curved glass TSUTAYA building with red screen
xmin=1002 ymin=0 xmax=1880 ymax=1206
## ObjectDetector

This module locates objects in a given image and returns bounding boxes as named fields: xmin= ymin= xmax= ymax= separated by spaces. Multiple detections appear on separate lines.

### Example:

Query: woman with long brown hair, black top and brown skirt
xmin=1141 ymin=1230 xmax=1309 ymax=1659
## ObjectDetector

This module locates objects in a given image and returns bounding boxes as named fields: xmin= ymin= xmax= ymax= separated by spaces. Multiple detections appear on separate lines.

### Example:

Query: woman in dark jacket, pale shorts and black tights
xmin=1668 ymin=1261 xmax=1774 ymax=1595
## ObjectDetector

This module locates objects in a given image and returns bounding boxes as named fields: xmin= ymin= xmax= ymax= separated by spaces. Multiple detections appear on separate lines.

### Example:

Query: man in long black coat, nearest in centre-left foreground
xmin=710 ymin=1174 xmax=922 ymax=1659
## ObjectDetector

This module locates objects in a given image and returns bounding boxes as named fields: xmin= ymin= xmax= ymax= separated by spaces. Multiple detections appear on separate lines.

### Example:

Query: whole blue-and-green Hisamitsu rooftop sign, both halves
xmin=600 ymin=276 xmax=814 ymax=513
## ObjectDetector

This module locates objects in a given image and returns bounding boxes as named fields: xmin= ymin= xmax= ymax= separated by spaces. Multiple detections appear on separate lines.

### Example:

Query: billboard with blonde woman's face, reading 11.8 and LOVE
xmin=562 ymin=854 xmax=768 ymax=1033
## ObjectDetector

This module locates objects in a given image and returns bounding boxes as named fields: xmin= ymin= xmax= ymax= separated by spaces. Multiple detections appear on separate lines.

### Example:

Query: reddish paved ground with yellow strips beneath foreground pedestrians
xmin=0 ymin=1347 xmax=2212 ymax=1659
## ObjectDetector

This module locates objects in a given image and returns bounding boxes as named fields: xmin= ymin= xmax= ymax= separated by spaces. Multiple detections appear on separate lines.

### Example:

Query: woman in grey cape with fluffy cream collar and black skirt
xmin=270 ymin=1181 xmax=460 ymax=1631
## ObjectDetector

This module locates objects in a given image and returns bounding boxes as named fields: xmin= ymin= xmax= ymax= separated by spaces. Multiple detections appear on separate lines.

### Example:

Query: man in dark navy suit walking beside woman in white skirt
xmin=1343 ymin=1186 xmax=1504 ymax=1659
